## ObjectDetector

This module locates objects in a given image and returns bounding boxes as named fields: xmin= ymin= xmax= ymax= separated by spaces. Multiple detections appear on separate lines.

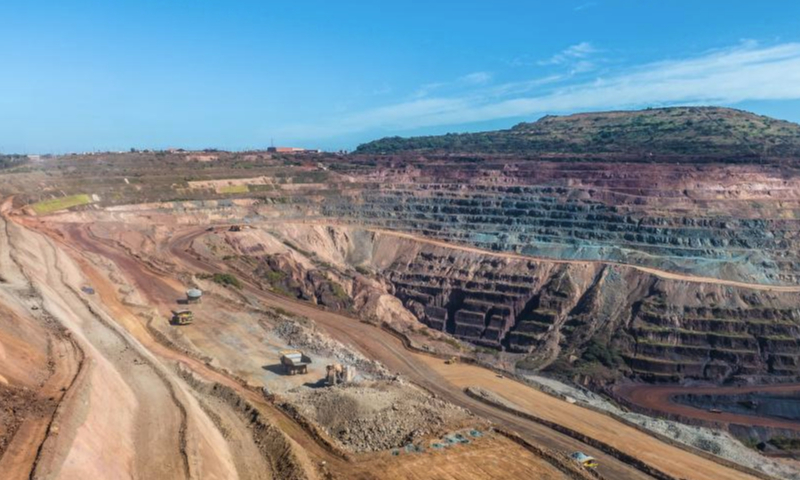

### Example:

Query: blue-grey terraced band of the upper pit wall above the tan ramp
xmin=321 ymin=185 xmax=800 ymax=284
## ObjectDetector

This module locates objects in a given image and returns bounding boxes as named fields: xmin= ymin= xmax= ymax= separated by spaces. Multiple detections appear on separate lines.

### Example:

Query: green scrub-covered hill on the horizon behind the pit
xmin=356 ymin=107 xmax=800 ymax=161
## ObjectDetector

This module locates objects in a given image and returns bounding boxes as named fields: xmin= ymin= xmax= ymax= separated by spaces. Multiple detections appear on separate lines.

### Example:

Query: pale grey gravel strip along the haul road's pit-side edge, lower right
xmin=525 ymin=375 xmax=800 ymax=480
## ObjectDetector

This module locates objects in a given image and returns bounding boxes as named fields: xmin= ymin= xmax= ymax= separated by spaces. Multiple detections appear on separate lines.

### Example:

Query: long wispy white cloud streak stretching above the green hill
xmin=276 ymin=43 xmax=800 ymax=138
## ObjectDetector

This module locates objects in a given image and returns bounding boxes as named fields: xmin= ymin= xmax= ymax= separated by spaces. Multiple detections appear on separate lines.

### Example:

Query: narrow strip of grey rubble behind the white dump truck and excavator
xmin=274 ymin=318 xmax=392 ymax=379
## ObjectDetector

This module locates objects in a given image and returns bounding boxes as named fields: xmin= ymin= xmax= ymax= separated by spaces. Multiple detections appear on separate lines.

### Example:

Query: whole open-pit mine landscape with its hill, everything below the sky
xmin=0 ymin=107 xmax=800 ymax=480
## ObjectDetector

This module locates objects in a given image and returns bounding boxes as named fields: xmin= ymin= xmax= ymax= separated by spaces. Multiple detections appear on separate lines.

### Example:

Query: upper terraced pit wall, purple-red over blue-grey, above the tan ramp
xmin=320 ymin=159 xmax=800 ymax=285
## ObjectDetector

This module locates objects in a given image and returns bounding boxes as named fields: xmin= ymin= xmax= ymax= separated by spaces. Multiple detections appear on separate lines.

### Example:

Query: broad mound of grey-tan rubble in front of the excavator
xmin=286 ymin=381 xmax=471 ymax=452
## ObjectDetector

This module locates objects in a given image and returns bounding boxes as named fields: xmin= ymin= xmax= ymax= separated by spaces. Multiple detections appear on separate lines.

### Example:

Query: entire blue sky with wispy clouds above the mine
xmin=0 ymin=0 xmax=800 ymax=153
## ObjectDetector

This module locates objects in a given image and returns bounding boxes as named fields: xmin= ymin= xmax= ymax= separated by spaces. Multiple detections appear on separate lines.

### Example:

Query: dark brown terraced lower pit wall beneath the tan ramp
xmin=278 ymin=226 xmax=800 ymax=382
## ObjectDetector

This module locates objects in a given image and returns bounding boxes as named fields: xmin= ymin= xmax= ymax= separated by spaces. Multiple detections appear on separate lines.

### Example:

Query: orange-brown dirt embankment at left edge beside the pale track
xmin=0 ymin=211 xmax=86 ymax=479
